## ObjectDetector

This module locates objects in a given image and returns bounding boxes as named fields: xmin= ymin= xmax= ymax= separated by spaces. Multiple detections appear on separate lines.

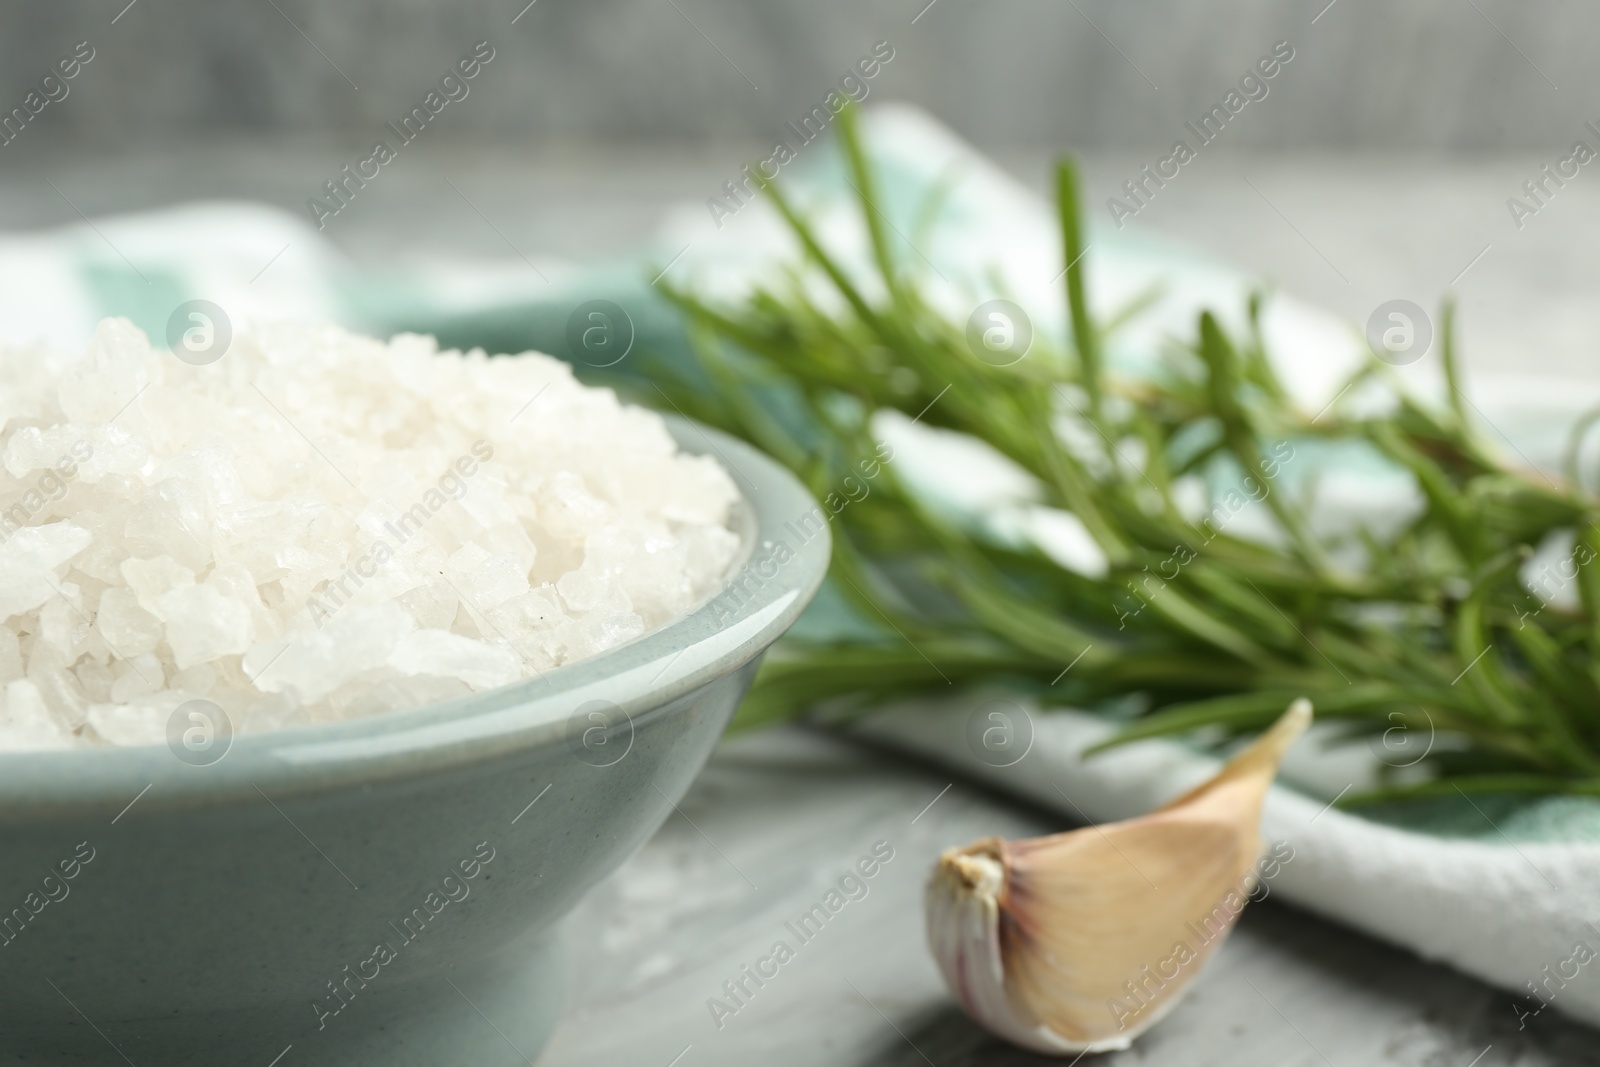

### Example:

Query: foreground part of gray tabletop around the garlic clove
xmin=540 ymin=729 xmax=1600 ymax=1067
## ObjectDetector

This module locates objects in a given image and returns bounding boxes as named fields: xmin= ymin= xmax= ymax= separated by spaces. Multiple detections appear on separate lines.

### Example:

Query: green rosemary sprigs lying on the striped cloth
xmin=661 ymin=110 xmax=1600 ymax=798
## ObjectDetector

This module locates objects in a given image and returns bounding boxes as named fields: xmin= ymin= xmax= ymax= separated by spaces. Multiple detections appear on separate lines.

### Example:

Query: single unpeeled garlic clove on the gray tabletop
xmin=926 ymin=699 xmax=1312 ymax=1054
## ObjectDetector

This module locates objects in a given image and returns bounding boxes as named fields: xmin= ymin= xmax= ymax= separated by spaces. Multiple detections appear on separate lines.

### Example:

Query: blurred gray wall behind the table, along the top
xmin=0 ymin=0 xmax=1600 ymax=152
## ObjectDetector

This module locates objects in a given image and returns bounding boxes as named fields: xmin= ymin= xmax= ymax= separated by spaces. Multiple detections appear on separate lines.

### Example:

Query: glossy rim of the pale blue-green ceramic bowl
xmin=0 ymin=413 xmax=832 ymax=824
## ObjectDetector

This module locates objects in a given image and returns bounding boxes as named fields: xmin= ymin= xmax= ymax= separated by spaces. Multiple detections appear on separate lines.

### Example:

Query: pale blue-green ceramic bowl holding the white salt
xmin=0 ymin=422 xmax=829 ymax=1067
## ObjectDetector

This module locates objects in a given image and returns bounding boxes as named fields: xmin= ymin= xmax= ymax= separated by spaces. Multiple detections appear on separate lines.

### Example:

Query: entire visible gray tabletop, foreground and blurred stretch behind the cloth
xmin=0 ymin=141 xmax=1600 ymax=1067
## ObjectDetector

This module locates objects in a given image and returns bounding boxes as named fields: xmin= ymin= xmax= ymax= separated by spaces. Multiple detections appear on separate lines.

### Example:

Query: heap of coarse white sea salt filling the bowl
xmin=0 ymin=320 xmax=739 ymax=750
